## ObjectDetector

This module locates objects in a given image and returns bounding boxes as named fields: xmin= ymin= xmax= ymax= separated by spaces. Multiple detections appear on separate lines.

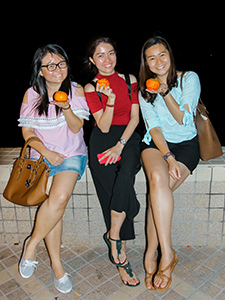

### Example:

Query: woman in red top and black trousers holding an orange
xmin=85 ymin=37 xmax=140 ymax=286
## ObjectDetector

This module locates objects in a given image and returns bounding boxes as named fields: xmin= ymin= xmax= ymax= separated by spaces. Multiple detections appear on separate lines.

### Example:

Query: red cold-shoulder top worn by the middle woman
xmin=85 ymin=72 xmax=139 ymax=125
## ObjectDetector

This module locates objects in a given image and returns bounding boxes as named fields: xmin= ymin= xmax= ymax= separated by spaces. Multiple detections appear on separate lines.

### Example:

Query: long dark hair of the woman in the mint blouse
xmin=139 ymin=36 xmax=177 ymax=103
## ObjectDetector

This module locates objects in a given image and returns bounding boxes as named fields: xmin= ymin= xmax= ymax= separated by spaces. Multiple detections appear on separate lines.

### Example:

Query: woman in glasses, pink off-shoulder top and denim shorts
xmin=19 ymin=44 xmax=89 ymax=293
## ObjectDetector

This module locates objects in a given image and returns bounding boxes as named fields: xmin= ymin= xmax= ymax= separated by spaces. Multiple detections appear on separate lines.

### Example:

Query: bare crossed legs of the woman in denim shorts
xmin=25 ymin=171 xmax=78 ymax=264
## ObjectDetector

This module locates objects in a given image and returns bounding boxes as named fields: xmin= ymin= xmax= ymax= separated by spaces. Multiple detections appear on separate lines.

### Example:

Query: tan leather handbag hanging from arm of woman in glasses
xmin=3 ymin=137 xmax=50 ymax=206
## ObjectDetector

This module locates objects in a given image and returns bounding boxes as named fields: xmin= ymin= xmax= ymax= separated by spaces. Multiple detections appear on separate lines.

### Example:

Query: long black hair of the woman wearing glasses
xmin=30 ymin=44 xmax=71 ymax=116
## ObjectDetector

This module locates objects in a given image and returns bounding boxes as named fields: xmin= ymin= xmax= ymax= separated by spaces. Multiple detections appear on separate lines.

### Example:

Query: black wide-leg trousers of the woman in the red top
xmin=89 ymin=125 xmax=141 ymax=240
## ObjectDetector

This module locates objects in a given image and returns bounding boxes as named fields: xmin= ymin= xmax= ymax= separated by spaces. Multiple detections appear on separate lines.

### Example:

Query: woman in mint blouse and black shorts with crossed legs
xmin=139 ymin=37 xmax=200 ymax=291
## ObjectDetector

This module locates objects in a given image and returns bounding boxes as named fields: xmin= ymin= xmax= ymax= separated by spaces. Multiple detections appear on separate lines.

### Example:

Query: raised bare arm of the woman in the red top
xmin=85 ymin=84 xmax=116 ymax=133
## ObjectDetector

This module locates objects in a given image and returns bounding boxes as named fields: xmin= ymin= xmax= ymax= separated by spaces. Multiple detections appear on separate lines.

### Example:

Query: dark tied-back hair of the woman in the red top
xmin=84 ymin=36 xmax=116 ymax=77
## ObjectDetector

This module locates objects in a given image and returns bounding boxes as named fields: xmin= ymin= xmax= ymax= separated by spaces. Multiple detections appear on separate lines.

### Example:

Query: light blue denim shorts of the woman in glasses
xmin=44 ymin=155 xmax=87 ymax=180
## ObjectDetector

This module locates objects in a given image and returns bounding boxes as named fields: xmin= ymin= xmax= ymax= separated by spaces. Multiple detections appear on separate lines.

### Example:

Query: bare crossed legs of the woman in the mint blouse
xmin=142 ymin=149 xmax=190 ymax=289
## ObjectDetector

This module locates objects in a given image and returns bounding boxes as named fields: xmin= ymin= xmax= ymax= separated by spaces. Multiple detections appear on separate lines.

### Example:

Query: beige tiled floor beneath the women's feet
xmin=0 ymin=245 xmax=225 ymax=300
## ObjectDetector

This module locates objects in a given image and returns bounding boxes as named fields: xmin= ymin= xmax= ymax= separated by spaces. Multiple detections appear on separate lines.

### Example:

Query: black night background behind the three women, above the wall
xmin=0 ymin=0 xmax=225 ymax=147
